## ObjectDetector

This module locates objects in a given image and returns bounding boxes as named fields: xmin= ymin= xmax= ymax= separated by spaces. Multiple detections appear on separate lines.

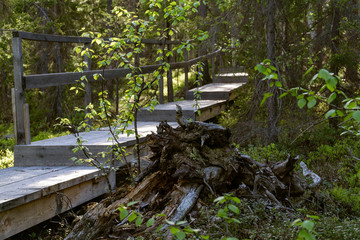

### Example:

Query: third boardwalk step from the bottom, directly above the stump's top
xmin=138 ymin=100 xmax=226 ymax=122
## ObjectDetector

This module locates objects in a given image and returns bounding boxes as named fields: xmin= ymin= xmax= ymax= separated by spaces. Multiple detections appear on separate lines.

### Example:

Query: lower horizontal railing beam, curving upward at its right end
xmin=23 ymin=49 xmax=221 ymax=89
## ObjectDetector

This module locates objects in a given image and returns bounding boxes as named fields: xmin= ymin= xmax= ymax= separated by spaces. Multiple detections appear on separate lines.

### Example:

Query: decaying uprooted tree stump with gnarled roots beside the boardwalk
xmin=66 ymin=107 xmax=312 ymax=239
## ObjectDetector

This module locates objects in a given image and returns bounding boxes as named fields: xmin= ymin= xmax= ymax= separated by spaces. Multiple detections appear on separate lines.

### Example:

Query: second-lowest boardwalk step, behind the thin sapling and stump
xmin=14 ymin=122 xmax=178 ymax=167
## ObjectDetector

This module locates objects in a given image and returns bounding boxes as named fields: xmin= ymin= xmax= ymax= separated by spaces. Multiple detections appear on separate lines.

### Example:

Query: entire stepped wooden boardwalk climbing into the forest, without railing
xmin=0 ymin=69 xmax=247 ymax=240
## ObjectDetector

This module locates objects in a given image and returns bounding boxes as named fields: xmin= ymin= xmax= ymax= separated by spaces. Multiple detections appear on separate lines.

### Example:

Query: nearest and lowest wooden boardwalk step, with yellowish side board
xmin=0 ymin=166 xmax=115 ymax=239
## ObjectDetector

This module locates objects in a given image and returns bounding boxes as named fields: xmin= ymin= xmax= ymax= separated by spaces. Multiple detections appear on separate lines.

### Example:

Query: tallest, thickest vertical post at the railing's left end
xmin=12 ymin=32 xmax=26 ymax=145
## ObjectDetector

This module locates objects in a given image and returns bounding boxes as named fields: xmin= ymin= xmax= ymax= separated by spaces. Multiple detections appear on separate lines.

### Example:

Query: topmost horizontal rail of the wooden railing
xmin=13 ymin=31 xmax=186 ymax=45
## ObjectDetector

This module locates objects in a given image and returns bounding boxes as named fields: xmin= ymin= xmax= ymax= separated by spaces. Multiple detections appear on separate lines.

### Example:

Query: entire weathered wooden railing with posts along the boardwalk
xmin=12 ymin=31 xmax=221 ymax=145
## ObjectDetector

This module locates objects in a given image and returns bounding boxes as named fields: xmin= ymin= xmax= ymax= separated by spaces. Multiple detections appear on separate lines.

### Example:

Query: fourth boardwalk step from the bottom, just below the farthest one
xmin=186 ymin=83 xmax=245 ymax=100
